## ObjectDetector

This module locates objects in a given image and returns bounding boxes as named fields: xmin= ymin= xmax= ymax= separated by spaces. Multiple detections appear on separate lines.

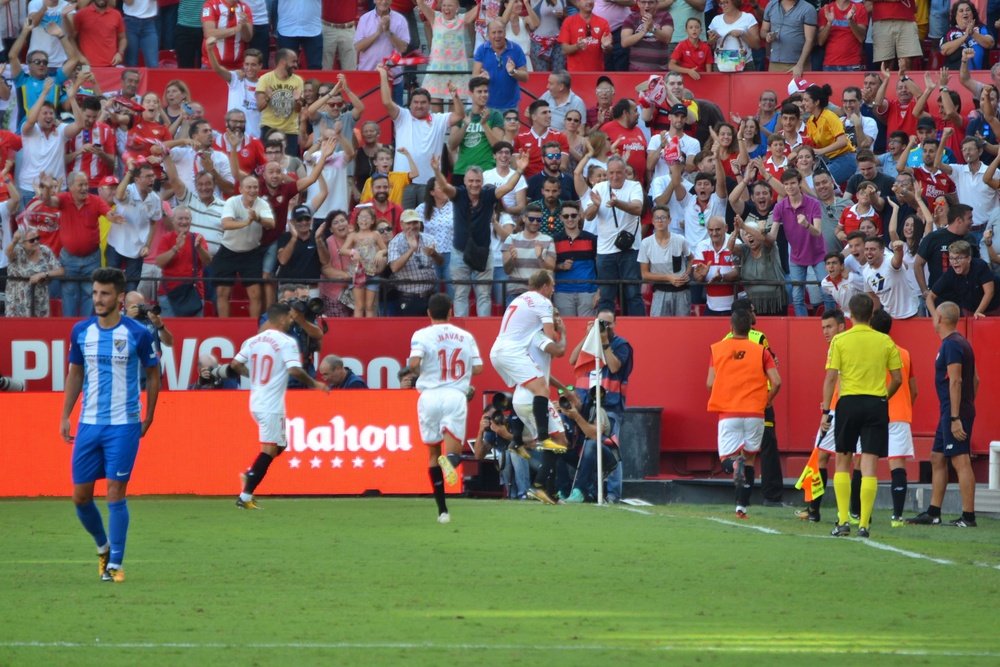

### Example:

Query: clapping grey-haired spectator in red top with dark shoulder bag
xmin=156 ymin=206 xmax=211 ymax=318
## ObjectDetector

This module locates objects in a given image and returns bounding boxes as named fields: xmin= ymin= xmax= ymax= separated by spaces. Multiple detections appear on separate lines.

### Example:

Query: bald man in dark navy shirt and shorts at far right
xmin=907 ymin=301 xmax=979 ymax=528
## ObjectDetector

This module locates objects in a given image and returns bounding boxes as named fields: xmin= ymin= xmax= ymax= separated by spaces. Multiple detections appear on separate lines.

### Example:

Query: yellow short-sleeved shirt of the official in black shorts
xmin=826 ymin=324 xmax=903 ymax=397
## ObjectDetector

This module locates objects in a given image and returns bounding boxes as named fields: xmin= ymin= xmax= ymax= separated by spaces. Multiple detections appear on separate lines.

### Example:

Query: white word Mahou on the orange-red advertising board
xmin=287 ymin=415 xmax=413 ymax=452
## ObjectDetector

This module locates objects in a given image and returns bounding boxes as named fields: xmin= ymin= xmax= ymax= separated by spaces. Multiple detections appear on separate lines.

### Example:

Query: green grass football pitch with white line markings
xmin=0 ymin=496 xmax=1000 ymax=667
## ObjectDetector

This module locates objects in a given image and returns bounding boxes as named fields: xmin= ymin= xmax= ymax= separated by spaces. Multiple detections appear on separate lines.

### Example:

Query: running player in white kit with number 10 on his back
xmin=228 ymin=303 xmax=330 ymax=510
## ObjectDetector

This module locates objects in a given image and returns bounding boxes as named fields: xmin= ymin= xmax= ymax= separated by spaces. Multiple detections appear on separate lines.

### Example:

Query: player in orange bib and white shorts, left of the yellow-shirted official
xmin=707 ymin=309 xmax=781 ymax=519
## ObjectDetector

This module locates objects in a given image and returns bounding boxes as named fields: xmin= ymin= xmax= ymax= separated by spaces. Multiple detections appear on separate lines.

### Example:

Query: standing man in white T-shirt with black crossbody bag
xmin=584 ymin=156 xmax=646 ymax=316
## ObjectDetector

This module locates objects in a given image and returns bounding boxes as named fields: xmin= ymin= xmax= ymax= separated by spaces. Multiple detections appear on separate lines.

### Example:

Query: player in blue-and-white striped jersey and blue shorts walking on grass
xmin=60 ymin=269 xmax=160 ymax=583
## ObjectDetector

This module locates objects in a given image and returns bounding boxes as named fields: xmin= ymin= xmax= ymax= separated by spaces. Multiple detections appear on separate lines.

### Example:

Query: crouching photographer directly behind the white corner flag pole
xmin=559 ymin=387 xmax=621 ymax=503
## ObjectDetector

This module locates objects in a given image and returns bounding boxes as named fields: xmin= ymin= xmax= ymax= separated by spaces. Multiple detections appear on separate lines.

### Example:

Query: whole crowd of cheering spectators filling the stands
xmin=0 ymin=0 xmax=1000 ymax=318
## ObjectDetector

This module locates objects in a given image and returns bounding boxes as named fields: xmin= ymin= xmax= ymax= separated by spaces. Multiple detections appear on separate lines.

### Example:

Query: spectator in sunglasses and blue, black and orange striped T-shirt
xmin=552 ymin=201 xmax=598 ymax=317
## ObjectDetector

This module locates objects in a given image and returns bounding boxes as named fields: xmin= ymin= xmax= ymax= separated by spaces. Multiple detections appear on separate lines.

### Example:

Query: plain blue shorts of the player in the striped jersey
xmin=73 ymin=424 xmax=142 ymax=484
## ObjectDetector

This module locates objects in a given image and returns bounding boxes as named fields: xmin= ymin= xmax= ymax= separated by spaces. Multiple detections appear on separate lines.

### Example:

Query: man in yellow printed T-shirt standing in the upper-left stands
xmin=255 ymin=49 xmax=304 ymax=157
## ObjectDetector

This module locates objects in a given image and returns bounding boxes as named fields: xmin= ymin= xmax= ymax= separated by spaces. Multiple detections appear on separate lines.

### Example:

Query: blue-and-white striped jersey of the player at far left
xmin=69 ymin=317 xmax=160 ymax=425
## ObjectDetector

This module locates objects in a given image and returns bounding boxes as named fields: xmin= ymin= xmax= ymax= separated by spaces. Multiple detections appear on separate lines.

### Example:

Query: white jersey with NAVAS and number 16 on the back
xmin=410 ymin=324 xmax=483 ymax=393
